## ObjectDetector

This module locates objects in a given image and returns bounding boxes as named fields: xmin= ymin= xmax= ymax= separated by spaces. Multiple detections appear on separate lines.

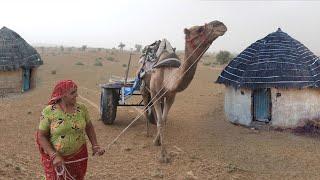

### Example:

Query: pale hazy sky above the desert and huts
xmin=0 ymin=0 xmax=320 ymax=55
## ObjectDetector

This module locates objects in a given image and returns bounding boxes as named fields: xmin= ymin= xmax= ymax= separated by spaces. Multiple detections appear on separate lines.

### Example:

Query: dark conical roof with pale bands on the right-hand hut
xmin=216 ymin=29 xmax=320 ymax=88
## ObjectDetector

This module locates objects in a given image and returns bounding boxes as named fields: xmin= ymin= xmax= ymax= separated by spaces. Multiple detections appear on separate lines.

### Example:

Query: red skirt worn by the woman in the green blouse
xmin=36 ymin=132 xmax=88 ymax=180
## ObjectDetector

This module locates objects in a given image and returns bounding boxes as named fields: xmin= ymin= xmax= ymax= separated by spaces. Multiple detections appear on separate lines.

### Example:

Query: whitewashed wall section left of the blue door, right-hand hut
xmin=224 ymin=86 xmax=252 ymax=126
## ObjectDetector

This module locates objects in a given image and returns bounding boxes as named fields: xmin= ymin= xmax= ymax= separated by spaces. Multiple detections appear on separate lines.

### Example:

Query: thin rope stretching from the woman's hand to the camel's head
xmin=107 ymin=27 xmax=213 ymax=149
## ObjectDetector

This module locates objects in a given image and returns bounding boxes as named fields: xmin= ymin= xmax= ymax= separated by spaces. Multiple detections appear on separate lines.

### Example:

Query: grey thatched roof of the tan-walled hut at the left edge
xmin=0 ymin=27 xmax=43 ymax=71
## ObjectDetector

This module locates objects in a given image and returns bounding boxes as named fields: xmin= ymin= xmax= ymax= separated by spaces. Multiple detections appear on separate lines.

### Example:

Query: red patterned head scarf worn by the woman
xmin=48 ymin=80 xmax=77 ymax=105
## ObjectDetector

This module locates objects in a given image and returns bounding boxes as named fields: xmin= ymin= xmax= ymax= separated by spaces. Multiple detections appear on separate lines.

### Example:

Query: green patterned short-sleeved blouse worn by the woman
xmin=39 ymin=103 xmax=90 ymax=156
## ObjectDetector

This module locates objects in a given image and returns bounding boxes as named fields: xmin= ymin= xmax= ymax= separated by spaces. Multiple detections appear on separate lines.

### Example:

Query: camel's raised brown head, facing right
xmin=184 ymin=21 xmax=227 ymax=48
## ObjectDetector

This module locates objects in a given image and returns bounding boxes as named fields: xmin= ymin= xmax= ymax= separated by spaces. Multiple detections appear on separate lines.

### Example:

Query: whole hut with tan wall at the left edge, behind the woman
xmin=0 ymin=27 xmax=43 ymax=95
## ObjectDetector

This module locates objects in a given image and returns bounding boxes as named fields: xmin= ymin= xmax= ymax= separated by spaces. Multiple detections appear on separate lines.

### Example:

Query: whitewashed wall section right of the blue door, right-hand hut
xmin=271 ymin=88 xmax=320 ymax=128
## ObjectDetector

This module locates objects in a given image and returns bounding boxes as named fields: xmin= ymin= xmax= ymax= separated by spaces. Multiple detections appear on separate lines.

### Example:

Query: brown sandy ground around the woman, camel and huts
xmin=0 ymin=49 xmax=320 ymax=180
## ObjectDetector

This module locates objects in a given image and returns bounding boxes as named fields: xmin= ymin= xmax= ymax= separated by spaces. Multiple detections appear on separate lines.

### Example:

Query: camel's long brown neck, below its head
xmin=172 ymin=42 xmax=209 ymax=92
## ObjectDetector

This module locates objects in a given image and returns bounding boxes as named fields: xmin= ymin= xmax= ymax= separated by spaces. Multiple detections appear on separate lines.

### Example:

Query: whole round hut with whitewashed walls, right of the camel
xmin=216 ymin=28 xmax=320 ymax=128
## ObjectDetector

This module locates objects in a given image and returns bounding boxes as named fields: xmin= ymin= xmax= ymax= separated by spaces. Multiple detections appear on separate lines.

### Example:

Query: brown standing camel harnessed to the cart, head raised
xmin=140 ymin=21 xmax=227 ymax=163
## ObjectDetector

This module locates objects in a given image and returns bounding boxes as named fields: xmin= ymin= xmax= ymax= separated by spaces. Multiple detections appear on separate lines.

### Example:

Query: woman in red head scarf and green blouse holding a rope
xmin=36 ymin=80 xmax=105 ymax=180
